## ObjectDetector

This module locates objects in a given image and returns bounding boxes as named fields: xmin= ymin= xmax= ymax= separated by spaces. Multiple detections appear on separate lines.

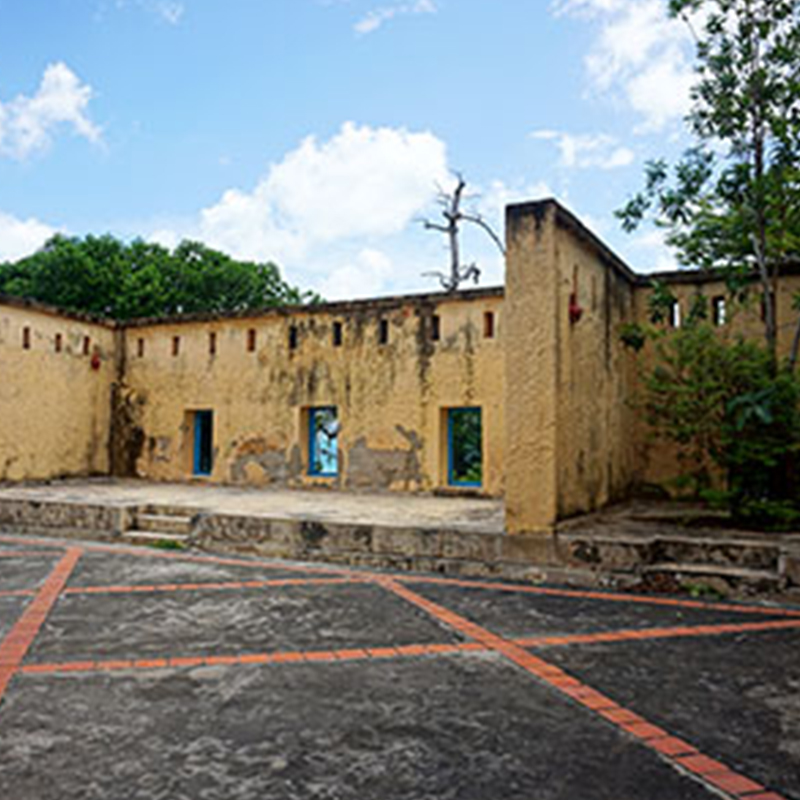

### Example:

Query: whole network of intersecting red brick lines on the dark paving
xmin=0 ymin=536 xmax=800 ymax=800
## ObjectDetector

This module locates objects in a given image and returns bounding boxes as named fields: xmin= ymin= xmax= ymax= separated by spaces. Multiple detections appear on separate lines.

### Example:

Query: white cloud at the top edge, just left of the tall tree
xmin=551 ymin=0 xmax=694 ymax=132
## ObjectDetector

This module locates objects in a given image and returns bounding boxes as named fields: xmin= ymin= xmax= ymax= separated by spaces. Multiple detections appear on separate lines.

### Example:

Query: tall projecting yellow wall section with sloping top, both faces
xmin=505 ymin=201 xmax=636 ymax=534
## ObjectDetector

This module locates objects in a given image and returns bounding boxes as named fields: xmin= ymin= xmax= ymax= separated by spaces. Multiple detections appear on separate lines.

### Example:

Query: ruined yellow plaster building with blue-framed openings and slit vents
xmin=0 ymin=200 xmax=798 ymax=534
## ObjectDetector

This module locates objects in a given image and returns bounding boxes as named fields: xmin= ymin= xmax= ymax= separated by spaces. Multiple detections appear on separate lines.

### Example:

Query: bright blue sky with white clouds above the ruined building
xmin=0 ymin=0 xmax=691 ymax=299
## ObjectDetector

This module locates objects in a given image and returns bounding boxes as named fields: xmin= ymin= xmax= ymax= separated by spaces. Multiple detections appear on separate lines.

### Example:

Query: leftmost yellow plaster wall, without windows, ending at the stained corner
xmin=0 ymin=301 xmax=116 ymax=481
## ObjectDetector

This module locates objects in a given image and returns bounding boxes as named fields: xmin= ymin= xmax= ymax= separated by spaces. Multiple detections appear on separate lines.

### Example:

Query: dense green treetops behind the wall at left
xmin=0 ymin=235 xmax=319 ymax=320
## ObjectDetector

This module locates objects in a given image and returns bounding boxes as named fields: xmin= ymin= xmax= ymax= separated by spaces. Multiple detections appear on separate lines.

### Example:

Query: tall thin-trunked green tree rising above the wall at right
xmin=617 ymin=0 xmax=800 ymax=364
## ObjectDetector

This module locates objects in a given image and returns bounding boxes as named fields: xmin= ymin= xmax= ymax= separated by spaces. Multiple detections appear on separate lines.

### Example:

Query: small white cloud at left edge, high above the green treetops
xmin=0 ymin=62 xmax=101 ymax=159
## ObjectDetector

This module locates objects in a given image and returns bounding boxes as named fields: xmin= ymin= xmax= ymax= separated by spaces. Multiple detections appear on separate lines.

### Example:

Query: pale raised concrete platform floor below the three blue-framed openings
xmin=0 ymin=478 xmax=504 ymax=533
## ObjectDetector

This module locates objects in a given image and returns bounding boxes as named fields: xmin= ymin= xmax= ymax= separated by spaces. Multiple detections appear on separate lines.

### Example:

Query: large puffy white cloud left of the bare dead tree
xmin=191 ymin=123 xmax=447 ymax=261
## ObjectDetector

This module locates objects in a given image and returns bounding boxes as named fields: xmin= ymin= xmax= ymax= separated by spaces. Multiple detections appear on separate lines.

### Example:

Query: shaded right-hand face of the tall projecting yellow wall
xmin=555 ymin=214 xmax=636 ymax=519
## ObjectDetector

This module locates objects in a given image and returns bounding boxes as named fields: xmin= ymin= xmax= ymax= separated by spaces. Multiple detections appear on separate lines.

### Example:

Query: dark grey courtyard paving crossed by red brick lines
xmin=0 ymin=535 xmax=800 ymax=800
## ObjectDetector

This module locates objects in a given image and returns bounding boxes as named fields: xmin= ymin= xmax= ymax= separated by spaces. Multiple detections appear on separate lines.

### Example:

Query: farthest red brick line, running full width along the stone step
xmin=0 ymin=536 xmax=800 ymax=617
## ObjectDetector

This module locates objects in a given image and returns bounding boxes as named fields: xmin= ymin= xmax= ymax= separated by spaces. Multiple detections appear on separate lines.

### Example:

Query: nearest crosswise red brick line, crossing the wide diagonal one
xmin=20 ymin=620 xmax=800 ymax=674
